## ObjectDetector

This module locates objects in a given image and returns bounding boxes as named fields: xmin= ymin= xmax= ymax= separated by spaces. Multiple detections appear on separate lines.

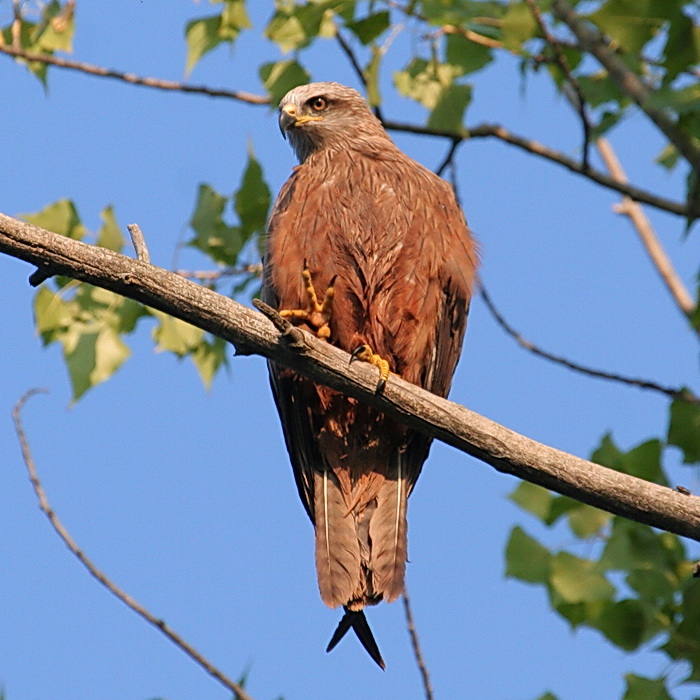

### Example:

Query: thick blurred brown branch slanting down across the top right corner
xmin=552 ymin=0 xmax=700 ymax=171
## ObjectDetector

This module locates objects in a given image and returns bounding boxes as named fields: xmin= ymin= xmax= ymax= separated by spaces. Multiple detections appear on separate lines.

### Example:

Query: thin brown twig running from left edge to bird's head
xmin=0 ymin=44 xmax=270 ymax=105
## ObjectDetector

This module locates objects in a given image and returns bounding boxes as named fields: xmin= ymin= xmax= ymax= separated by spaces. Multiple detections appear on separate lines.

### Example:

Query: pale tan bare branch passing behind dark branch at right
xmin=596 ymin=138 xmax=695 ymax=328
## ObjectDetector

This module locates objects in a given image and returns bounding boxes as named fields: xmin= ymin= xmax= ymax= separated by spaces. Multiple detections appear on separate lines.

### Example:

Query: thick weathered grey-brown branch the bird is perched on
xmin=0 ymin=214 xmax=700 ymax=541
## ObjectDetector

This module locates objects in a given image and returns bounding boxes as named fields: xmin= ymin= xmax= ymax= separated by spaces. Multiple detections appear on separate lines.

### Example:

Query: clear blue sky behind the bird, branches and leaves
xmin=0 ymin=0 xmax=700 ymax=700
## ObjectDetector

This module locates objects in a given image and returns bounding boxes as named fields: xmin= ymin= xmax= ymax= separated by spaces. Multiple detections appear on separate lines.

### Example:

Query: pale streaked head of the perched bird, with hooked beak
xmin=279 ymin=83 xmax=389 ymax=162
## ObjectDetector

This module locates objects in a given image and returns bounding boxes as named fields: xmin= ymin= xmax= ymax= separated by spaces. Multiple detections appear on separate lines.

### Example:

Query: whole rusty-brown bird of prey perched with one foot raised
xmin=263 ymin=83 xmax=478 ymax=668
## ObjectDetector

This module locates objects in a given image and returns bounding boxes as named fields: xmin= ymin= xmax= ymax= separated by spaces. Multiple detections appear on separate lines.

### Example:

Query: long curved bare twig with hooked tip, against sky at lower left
xmin=12 ymin=389 xmax=252 ymax=700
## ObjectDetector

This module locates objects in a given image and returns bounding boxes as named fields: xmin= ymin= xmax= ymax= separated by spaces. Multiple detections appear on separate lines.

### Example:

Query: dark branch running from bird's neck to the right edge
xmin=383 ymin=119 xmax=700 ymax=218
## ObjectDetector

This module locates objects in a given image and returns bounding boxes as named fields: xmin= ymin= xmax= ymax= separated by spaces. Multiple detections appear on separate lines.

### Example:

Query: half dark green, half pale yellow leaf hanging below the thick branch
xmin=64 ymin=326 xmax=131 ymax=401
